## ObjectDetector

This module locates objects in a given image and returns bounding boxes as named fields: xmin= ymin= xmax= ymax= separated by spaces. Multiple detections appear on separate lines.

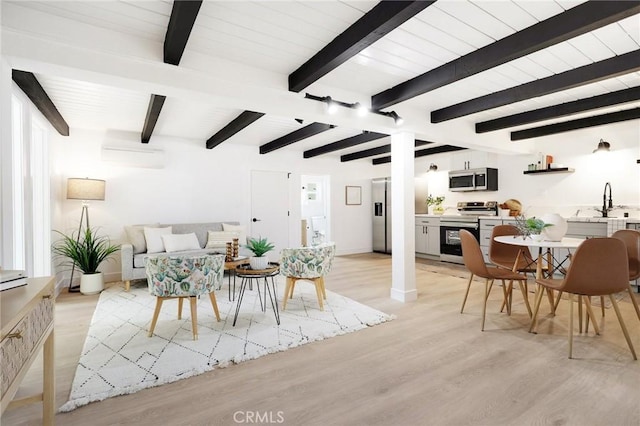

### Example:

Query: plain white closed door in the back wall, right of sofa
xmin=250 ymin=170 xmax=290 ymax=262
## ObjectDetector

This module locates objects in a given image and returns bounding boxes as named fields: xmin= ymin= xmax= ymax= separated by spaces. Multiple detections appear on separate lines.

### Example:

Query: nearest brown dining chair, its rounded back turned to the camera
xmin=531 ymin=238 xmax=638 ymax=359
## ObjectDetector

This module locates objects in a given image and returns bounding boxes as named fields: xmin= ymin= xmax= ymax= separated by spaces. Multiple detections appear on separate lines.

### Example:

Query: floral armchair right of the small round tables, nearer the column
xmin=280 ymin=243 xmax=336 ymax=310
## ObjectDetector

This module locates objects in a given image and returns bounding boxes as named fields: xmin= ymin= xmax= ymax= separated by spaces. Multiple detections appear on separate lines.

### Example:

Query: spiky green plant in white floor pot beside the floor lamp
xmin=52 ymin=228 xmax=120 ymax=294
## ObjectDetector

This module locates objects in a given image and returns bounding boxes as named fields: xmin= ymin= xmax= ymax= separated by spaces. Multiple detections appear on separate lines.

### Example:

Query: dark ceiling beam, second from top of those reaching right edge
xmin=431 ymin=50 xmax=640 ymax=123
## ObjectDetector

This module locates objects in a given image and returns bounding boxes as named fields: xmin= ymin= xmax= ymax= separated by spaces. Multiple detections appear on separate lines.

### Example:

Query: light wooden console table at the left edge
xmin=0 ymin=277 xmax=55 ymax=425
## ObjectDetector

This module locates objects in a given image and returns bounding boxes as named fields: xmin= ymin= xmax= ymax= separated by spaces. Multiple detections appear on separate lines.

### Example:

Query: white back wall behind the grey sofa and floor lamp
xmin=51 ymin=129 xmax=374 ymax=280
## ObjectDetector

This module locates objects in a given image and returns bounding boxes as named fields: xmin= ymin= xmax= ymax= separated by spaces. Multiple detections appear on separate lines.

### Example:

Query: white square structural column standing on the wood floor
xmin=391 ymin=132 xmax=418 ymax=302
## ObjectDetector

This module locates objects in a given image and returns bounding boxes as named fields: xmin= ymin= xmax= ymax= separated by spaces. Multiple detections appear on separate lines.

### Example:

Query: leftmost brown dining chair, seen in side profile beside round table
xmin=460 ymin=229 xmax=527 ymax=331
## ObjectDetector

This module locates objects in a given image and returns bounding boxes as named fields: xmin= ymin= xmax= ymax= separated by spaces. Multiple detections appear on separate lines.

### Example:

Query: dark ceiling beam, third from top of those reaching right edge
xmin=476 ymin=86 xmax=640 ymax=133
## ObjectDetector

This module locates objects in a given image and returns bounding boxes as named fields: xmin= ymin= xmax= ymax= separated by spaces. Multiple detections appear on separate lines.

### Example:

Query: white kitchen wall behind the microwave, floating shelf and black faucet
xmin=415 ymin=120 xmax=640 ymax=217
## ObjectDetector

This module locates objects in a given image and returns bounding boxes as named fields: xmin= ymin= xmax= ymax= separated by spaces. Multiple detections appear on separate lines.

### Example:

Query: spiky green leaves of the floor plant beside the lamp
xmin=52 ymin=228 xmax=120 ymax=274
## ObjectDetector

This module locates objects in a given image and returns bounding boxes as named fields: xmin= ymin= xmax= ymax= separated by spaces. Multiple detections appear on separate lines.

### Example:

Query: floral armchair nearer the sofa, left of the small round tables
xmin=145 ymin=255 xmax=224 ymax=340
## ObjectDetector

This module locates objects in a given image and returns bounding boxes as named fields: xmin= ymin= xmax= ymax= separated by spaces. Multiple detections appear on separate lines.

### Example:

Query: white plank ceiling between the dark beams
xmin=0 ymin=0 xmax=640 ymax=161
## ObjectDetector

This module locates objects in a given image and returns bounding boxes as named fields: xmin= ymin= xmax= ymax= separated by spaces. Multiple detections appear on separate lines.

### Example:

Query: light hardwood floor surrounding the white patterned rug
xmin=2 ymin=254 xmax=640 ymax=426
